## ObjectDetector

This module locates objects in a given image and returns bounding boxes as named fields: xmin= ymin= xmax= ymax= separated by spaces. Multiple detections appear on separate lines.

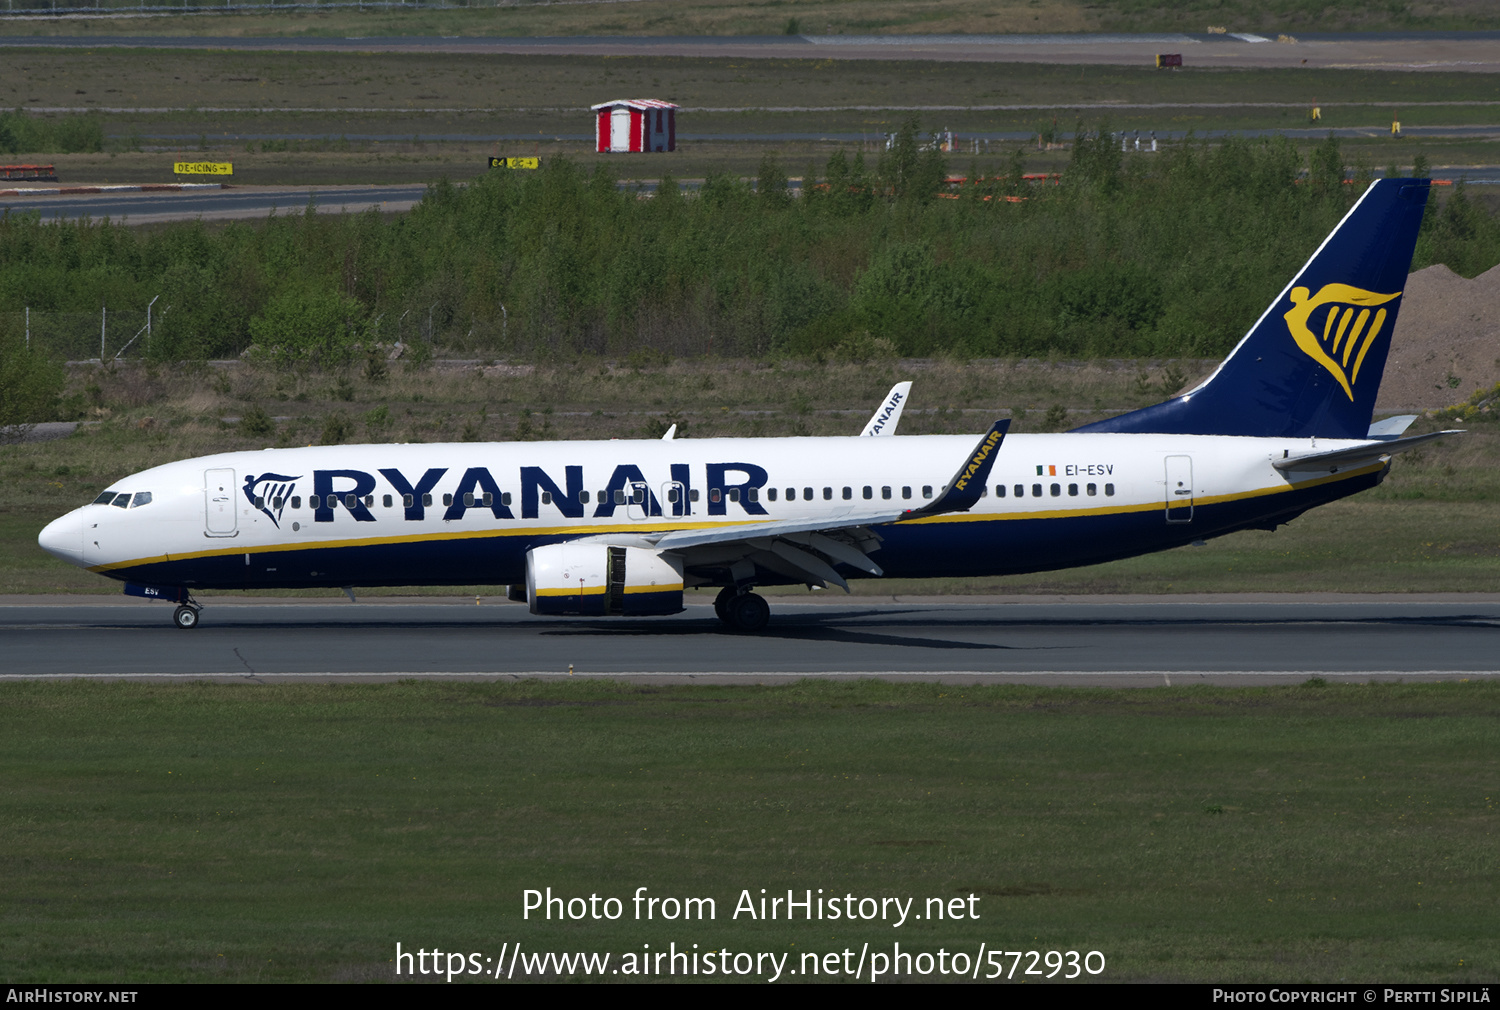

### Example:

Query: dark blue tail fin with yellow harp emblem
xmin=1077 ymin=179 xmax=1428 ymax=438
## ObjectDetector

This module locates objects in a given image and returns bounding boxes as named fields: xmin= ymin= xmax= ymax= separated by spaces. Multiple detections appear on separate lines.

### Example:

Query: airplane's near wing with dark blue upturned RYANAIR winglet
xmin=654 ymin=419 xmax=1011 ymax=593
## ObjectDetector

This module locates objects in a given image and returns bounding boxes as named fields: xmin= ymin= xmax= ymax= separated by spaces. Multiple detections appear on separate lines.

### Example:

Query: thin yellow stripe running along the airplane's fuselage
xmin=87 ymin=462 xmax=1388 ymax=573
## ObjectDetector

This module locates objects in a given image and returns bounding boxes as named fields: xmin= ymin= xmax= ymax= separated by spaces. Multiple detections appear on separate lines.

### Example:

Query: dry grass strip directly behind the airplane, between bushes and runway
xmin=0 ymin=360 xmax=1500 ymax=594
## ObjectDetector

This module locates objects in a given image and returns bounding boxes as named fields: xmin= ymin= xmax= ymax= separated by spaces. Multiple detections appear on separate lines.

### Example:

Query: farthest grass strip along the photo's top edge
xmin=0 ymin=0 xmax=1500 ymax=36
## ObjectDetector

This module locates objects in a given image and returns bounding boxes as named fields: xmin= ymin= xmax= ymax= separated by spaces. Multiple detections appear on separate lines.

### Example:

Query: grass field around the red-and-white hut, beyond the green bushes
xmin=11 ymin=50 xmax=1500 ymax=185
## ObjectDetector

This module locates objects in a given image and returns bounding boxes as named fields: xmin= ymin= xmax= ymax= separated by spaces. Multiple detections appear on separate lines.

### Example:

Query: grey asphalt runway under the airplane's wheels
xmin=0 ymin=594 xmax=1500 ymax=686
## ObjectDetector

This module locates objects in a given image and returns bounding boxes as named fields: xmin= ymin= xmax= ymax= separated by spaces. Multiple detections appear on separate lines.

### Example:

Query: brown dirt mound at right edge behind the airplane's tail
xmin=1376 ymin=264 xmax=1500 ymax=411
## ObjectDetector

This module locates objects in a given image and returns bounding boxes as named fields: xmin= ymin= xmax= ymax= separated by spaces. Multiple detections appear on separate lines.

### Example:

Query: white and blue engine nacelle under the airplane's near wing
xmin=527 ymin=543 xmax=683 ymax=617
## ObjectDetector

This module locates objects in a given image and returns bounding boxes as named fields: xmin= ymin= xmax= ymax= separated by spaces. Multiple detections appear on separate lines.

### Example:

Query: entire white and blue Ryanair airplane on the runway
xmin=39 ymin=179 xmax=1458 ymax=633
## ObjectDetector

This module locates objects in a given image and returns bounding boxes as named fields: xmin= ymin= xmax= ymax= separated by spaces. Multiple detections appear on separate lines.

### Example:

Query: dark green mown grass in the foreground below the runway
xmin=0 ymin=681 xmax=1500 ymax=981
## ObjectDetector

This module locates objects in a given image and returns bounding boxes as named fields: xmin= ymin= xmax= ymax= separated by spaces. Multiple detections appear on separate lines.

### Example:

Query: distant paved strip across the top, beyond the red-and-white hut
xmin=0 ymin=32 xmax=1500 ymax=72
